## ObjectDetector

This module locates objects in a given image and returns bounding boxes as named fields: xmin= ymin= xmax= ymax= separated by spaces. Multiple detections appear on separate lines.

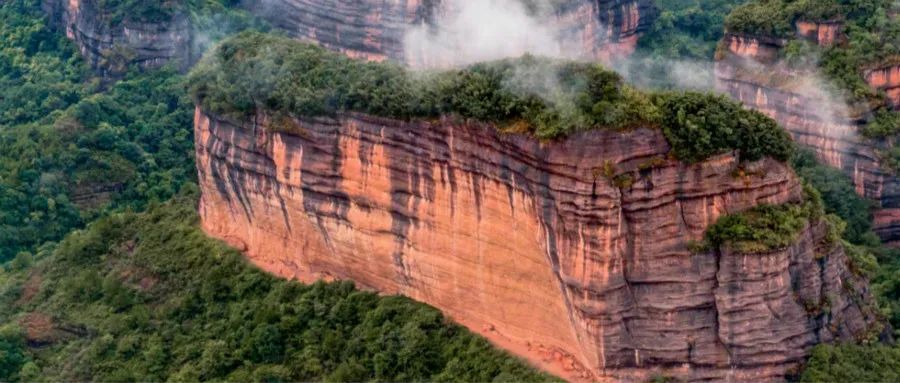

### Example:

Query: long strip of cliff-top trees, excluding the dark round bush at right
xmin=190 ymin=33 xmax=658 ymax=138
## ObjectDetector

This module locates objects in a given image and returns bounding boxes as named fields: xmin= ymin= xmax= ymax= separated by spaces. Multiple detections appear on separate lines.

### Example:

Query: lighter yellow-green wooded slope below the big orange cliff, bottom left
xmin=0 ymin=192 xmax=552 ymax=381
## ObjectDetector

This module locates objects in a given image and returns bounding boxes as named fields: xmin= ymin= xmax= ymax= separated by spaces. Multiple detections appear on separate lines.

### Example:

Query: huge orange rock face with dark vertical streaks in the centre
xmin=195 ymin=109 xmax=874 ymax=381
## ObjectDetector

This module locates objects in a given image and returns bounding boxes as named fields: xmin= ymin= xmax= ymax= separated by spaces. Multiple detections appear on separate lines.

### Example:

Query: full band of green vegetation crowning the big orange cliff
xmin=190 ymin=32 xmax=792 ymax=162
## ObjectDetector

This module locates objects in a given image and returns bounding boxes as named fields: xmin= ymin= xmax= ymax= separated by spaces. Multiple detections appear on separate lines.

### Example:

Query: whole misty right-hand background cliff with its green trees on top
xmin=715 ymin=0 xmax=900 ymax=245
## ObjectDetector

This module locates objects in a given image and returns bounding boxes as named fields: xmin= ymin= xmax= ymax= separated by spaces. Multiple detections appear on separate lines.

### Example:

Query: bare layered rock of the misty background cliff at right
xmin=715 ymin=32 xmax=900 ymax=245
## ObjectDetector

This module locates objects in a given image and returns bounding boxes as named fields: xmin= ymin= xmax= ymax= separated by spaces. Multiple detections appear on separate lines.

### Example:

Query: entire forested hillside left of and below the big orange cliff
xmin=0 ymin=0 xmax=552 ymax=381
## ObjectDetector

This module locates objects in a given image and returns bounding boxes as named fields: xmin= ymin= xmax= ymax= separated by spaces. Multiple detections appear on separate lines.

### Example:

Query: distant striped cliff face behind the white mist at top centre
xmin=244 ymin=0 xmax=657 ymax=61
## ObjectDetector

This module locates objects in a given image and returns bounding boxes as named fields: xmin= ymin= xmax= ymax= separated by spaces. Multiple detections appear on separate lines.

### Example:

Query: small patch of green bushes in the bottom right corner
xmin=800 ymin=345 xmax=900 ymax=382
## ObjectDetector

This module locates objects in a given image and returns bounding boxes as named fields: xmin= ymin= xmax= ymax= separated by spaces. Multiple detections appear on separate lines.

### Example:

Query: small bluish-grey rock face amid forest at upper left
xmin=42 ymin=0 xmax=194 ymax=75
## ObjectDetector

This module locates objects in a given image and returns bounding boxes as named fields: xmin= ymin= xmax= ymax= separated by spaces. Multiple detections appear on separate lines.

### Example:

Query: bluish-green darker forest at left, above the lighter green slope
xmin=0 ymin=0 xmax=268 ymax=262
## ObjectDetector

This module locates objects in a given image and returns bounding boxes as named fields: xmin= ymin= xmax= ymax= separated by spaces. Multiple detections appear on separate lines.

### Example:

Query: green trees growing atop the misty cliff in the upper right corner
xmin=725 ymin=0 xmax=900 ymax=172
